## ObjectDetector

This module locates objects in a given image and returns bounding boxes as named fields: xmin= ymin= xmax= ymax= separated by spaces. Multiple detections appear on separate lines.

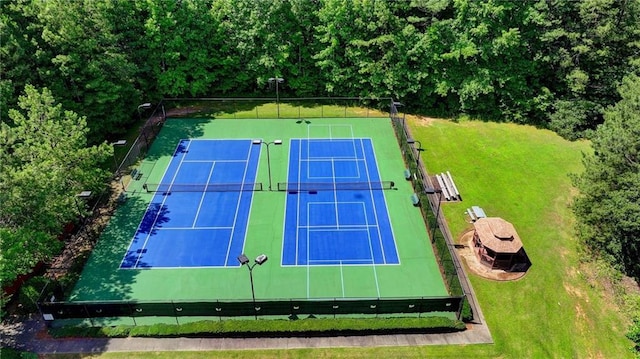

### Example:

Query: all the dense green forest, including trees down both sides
xmin=0 ymin=0 xmax=640 ymax=334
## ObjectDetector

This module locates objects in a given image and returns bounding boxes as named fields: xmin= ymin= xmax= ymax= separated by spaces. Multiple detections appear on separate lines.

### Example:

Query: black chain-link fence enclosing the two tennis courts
xmin=38 ymin=98 xmax=476 ymax=323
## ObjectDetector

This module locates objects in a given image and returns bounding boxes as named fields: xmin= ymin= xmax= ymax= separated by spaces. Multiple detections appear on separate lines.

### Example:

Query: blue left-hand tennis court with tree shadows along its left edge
xmin=120 ymin=140 xmax=261 ymax=268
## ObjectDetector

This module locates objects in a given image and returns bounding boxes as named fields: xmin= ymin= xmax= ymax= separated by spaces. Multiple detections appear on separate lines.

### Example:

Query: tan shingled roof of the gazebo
xmin=473 ymin=217 xmax=522 ymax=253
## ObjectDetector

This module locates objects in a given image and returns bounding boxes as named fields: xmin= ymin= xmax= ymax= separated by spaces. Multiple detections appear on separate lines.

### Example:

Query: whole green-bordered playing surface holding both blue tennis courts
xmin=70 ymin=118 xmax=448 ymax=310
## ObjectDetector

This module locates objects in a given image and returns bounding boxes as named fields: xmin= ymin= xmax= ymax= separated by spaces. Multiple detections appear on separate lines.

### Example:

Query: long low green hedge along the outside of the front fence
xmin=49 ymin=317 xmax=465 ymax=338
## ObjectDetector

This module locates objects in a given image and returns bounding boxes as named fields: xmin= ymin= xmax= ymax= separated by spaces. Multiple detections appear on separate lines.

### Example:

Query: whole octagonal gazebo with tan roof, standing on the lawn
xmin=473 ymin=217 xmax=531 ymax=272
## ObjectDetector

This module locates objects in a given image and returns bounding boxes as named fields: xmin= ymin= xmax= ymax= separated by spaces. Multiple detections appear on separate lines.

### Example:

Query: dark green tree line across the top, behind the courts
xmin=0 ymin=0 xmax=640 ymax=143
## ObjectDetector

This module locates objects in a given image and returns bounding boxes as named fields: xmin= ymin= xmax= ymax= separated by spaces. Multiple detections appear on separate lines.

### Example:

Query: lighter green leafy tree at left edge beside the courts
xmin=0 ymin=86 xmax=113 ymax=280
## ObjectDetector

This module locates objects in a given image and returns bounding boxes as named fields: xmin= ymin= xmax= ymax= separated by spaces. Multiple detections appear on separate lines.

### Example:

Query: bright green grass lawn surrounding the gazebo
xmin=43 ymin=119 xmax=633 ymax=359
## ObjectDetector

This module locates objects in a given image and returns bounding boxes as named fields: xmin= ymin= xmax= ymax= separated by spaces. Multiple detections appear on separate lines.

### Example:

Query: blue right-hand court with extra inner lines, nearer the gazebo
xmin=282 ymin=138 xmax=399 ymax=266
